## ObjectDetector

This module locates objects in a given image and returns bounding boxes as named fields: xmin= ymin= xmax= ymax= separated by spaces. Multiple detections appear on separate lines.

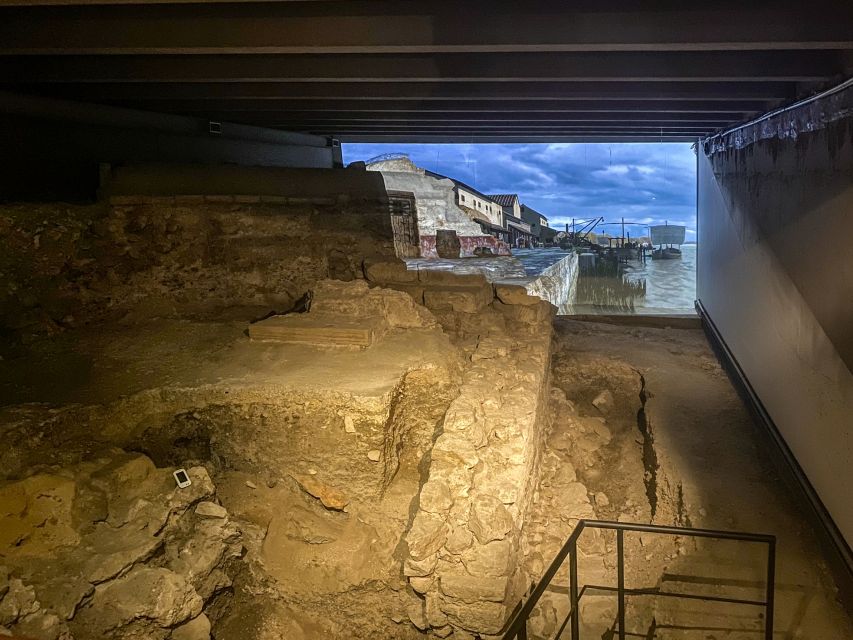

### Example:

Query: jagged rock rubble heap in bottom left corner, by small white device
xmin=0 ymin=449 xmax=242 ymax=640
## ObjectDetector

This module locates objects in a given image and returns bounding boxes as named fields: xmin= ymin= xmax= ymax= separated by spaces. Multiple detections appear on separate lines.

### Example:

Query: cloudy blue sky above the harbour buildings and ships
xmin=343 ymin=143 xmax=696 ymax=241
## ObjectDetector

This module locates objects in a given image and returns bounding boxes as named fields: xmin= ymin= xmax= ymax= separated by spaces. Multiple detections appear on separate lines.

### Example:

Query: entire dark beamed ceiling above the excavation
xmin=0 ymin=0 xmax=853 ymax=142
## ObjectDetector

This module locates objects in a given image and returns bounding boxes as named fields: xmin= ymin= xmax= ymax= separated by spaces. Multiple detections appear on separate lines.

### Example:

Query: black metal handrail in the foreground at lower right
xmin=503 ymin=520 xmax=776 ymax=640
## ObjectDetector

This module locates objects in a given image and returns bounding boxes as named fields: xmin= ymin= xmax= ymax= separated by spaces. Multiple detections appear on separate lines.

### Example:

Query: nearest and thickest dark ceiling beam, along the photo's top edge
xmin=0 ymin=0 xmax=853 ymax=55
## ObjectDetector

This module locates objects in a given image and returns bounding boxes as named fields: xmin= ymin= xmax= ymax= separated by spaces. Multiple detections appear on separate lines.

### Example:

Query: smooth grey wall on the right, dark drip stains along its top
xmin=697 ymin=118 xmax=853 ymax=544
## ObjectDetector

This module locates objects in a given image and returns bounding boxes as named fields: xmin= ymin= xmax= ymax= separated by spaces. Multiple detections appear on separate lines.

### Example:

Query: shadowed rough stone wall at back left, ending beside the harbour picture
xmin=0 ymin=179 xmax=394 ymax=337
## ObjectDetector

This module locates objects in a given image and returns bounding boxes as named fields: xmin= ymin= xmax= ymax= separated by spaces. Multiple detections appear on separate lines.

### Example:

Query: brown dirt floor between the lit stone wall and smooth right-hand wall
xmin=525 ymin=318 xmax=853 ymax=640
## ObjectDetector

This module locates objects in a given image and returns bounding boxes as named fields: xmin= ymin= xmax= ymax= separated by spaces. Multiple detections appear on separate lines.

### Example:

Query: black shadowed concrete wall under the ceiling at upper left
xmin=0 ymin=92 xmax=342 ymax=202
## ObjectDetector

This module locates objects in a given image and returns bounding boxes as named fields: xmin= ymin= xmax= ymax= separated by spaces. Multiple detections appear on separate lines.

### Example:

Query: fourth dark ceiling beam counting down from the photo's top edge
xmin=91 ymin=98 xmax=767 ymax=118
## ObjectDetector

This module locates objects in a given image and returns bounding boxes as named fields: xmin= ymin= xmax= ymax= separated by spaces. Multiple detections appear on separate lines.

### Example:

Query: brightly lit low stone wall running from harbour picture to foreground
xmin=365 ymin=263 xmax=554 ymax=638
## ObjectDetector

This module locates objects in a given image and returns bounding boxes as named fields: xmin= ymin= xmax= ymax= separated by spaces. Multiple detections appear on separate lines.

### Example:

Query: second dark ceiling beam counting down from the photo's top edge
xmin=0 ymin=51 xmax=851 ymax=84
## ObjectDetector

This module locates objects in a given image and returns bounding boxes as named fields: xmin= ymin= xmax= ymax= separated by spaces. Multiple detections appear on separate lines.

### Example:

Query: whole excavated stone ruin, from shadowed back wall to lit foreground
xmin=0 ymin=179 xmax=848 ymax=640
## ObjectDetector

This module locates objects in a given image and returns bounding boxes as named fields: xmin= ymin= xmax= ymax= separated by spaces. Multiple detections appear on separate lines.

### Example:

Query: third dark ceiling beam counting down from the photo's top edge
xmin=10 ymin=82 xmax=799 ymax=103
